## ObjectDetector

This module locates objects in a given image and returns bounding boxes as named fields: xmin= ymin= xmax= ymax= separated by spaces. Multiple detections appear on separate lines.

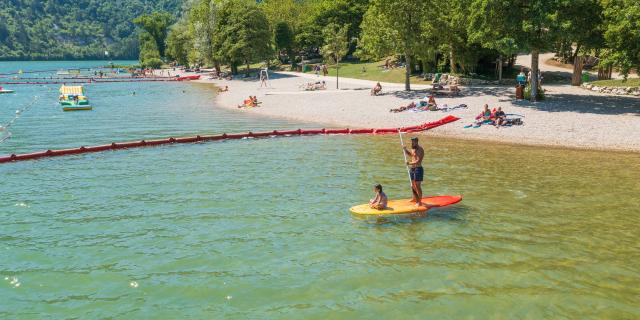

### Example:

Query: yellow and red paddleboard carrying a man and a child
xmin=349 ymin=196 xmax=462 ymax=216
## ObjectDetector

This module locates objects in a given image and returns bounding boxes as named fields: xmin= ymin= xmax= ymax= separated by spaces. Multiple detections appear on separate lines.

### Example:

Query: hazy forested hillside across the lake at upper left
xmin=0 ymin=0 xmax=183 ymax=60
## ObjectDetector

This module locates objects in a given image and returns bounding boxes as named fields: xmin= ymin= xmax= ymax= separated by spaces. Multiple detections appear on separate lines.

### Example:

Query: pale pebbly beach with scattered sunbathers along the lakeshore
xmin=169 ymin=68 xmax=640 ymax=152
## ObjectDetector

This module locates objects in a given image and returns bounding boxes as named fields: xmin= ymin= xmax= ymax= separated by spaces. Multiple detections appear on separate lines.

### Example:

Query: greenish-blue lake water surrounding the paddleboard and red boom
xmin=0 ymin=62 xmax=640 ymax=319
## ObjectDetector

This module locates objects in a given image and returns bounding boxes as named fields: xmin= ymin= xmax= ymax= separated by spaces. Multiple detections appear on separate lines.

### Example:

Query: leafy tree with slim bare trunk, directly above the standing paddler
xmin=358 ymin=0 xmax=430 ymax=90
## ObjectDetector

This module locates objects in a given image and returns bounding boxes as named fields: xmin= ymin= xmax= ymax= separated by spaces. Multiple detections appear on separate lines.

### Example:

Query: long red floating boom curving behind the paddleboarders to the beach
xmin=0 ymin=115 xmax=460 ymax=163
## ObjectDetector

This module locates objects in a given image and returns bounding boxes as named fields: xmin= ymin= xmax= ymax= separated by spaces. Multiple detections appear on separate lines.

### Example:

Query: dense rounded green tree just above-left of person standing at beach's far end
xmin=212 ymin=0 xmax=272 ymax=74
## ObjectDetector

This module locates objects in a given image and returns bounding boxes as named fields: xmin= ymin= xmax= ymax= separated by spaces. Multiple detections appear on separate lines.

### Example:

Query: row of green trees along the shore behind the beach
xmin=136 ymin=0 xmax=640 ymax=97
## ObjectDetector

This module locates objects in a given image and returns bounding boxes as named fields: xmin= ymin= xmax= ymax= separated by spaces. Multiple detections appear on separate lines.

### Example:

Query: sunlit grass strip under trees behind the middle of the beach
xmin=308 ymin=61 xmax=431 ymax=84
